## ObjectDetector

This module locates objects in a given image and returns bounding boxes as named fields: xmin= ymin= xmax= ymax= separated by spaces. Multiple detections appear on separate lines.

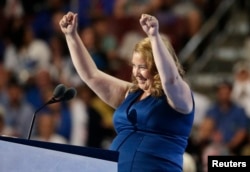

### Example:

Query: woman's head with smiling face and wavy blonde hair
xmin=129 ymin=35 xmax=184 ymax=97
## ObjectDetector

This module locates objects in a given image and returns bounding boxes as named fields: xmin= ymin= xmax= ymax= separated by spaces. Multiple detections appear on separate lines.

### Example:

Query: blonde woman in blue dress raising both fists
xmin=60 ymin=12 xmax=194 ymax=172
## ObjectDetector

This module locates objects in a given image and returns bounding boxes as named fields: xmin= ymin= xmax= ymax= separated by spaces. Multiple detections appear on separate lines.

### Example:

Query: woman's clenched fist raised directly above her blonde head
xmin=140 ymin=14 xmax=159 ymax=36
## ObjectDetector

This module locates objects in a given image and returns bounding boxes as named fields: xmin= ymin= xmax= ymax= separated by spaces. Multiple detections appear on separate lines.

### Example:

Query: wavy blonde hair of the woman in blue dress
xmin=129 ymin=35 xmax=185 ymax=97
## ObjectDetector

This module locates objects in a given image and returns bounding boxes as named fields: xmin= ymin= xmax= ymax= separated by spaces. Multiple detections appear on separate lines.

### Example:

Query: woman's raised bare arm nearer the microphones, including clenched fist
xmin=59 ymin=12 xmax=130 ymax=108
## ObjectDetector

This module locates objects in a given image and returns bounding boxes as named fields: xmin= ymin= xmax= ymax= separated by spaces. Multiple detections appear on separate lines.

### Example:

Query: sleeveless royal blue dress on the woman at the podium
xmin=110 ymin=90 xmax=194 ymax=172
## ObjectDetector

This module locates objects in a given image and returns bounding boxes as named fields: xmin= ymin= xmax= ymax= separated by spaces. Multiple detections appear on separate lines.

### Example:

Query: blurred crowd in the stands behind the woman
xmin=0 ymin=0 xmax=250 ymax=172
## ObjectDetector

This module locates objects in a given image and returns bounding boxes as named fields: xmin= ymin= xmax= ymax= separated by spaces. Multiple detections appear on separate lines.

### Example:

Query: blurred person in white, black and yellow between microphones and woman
xmin=70 ymin=84 xmax=114 ymax=148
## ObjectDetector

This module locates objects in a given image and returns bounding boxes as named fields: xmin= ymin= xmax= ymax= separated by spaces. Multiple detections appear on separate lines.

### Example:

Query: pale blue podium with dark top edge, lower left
xmin=0 ymin=136 xmax=119 ymax=172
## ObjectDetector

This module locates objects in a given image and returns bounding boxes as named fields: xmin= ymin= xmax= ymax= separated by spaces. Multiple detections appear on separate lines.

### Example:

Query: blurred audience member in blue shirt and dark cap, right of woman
xmin=199 ymin=81 xmax=247 ymax=155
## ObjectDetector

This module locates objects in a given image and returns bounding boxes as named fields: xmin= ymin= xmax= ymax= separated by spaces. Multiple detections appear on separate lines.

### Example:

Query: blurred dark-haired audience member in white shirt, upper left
xmin=4 ymin=19 xmax=51 ymax=83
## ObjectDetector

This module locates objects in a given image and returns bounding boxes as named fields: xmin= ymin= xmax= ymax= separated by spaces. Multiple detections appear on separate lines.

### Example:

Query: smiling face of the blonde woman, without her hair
xmin=132 ymin=52 xmax=153 ymax=92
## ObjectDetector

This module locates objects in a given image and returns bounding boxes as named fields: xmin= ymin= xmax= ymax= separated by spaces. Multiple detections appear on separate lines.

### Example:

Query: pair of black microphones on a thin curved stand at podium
xmin=27 ymin=84 xmax=77 ymax=140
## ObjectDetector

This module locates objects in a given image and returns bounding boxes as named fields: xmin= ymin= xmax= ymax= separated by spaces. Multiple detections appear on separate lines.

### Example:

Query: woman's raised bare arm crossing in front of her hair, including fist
xmin=140 ymin=14 xmax=193 ymax=114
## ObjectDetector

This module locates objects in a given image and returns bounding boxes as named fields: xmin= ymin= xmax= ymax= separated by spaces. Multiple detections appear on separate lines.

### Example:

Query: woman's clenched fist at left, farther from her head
xmin=59 ymin=12 xmax=77 ymax=35
